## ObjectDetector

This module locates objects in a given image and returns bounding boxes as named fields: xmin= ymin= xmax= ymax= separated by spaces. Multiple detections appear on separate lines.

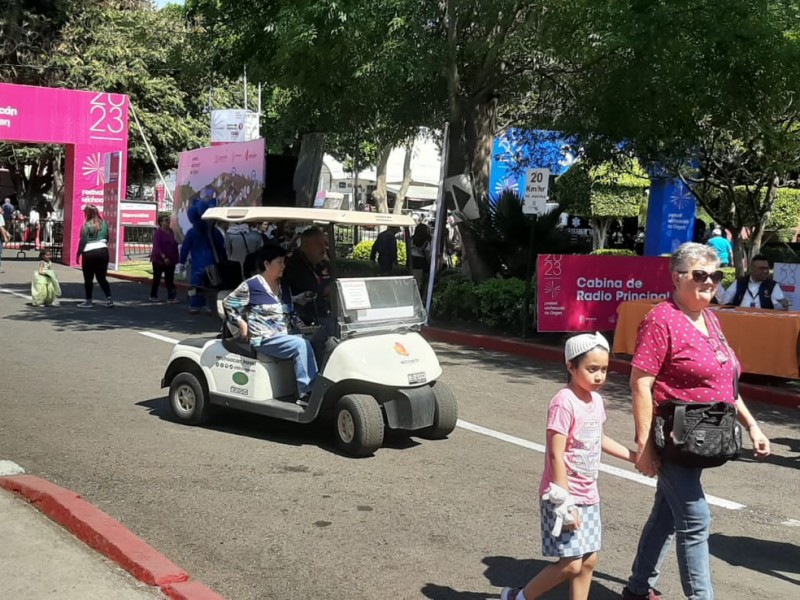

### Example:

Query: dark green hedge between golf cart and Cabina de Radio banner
xmin=431 ymin=275 xmax=535 ymax=330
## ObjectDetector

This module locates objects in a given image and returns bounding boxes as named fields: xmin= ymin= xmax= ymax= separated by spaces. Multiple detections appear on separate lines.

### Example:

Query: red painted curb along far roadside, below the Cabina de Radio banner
xmin=422 ymin=327 xmax=800 ymax=408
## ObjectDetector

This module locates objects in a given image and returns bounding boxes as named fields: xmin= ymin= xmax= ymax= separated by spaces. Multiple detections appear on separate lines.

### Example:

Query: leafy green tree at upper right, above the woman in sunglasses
xmin=557 ymin=0 xmax=800 ymax=273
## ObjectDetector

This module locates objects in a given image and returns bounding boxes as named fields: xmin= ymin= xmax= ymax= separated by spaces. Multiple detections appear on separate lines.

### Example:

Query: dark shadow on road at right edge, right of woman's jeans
xmin=708 ymin=533 xmax=800 ymax=594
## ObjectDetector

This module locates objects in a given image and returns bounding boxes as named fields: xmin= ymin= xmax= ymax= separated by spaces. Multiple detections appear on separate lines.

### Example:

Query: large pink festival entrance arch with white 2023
xmin=0 ymin=83 xmax=128 ymax=266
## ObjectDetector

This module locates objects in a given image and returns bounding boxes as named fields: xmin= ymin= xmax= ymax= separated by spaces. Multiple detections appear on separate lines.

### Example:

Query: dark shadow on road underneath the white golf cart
xmin=136 ymin=397 xmax=424 ymax=458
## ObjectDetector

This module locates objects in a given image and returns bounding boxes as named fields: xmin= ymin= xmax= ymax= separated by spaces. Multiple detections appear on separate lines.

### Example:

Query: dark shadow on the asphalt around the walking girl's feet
xmin=422 ymin=556 xmax=626 ymax=600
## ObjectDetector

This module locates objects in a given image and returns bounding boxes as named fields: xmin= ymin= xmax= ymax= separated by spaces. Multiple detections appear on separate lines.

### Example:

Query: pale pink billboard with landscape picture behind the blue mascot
xmin=173 ymin=139 xmax=264 ymax=231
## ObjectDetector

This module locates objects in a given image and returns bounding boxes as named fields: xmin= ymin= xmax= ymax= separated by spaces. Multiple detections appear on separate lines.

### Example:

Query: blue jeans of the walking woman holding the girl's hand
xmin=628 ymin=462 xmax=714 ymax=600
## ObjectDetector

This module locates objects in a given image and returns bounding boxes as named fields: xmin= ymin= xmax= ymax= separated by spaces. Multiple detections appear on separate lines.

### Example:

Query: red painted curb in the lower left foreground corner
xmin=0 ymin=475 xmax=224 ymax=600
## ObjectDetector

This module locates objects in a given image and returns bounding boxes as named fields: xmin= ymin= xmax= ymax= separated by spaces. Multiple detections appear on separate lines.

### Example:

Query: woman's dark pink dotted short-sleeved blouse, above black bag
xmin=631 ymin=300 xmax=739 ymax=404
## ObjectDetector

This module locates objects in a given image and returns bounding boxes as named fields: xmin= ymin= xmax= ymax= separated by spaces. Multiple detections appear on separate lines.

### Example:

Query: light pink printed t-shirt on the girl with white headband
xmin=539 ymin=388 xmax=606 ymax=505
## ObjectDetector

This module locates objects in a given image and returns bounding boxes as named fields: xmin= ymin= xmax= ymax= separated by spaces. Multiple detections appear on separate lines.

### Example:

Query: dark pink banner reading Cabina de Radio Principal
xmin=536 ymin=254 xmax=672 ymax=331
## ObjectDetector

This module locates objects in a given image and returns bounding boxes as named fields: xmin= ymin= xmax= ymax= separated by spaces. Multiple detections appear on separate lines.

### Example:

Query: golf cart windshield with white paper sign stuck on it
xmin=336 ymin=277 xmax=427 ymax=337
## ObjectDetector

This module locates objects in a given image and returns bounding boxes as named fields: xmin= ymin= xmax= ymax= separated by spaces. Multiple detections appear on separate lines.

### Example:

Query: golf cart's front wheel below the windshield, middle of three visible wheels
xmin=334 ymin=394 xmax=383 ymax=456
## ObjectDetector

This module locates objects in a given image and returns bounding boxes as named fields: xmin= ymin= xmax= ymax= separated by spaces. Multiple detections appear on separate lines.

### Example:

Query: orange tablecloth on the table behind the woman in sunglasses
xmin=614 ymin=300 xmax=800 ymax=379
